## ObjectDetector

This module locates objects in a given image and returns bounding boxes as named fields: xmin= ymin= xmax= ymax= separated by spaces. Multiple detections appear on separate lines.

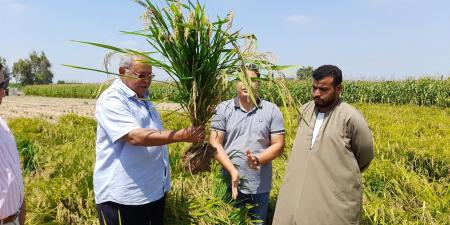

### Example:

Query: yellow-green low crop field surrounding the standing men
xmin=8 ymin=103 xmax=450 ymax=225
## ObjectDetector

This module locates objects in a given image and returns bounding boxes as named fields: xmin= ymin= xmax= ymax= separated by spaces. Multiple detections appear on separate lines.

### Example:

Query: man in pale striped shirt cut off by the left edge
xmin=0 ymin=64 xmax=25 ymax=225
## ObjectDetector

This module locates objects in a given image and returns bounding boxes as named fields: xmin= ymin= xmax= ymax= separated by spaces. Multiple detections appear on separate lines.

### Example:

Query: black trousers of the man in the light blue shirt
xmin=97 ymin=195 xmax=166 ymax=225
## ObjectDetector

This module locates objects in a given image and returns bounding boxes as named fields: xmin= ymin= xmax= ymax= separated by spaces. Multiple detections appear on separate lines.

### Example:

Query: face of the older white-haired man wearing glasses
xmin=119 ymin=62 xmax=153 ymax=98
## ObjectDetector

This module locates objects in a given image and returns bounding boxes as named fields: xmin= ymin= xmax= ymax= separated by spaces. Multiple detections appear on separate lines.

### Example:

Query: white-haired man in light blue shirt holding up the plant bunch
xmin=94 ymin=55 xmax=205 ymax=225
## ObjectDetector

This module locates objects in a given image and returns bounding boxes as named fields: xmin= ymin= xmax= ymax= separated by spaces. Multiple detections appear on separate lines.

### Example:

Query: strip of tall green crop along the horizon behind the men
xmin=23 ymin=78 xmax=450 ymax=107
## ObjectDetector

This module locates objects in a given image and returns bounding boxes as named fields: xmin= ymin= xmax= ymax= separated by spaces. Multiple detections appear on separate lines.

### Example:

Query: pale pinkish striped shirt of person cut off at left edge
xmin=0 ymin=117 xmax=24 ymax=219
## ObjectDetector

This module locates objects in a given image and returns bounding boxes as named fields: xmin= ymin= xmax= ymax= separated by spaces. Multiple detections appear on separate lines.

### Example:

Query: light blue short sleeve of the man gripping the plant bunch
xmin=96 ymin=96 xmax=140 ymax=142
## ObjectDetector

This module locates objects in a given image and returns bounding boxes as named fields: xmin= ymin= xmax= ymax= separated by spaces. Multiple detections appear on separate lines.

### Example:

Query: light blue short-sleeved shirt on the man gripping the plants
xmin=94 ymin=79 xmax=170 ymax=205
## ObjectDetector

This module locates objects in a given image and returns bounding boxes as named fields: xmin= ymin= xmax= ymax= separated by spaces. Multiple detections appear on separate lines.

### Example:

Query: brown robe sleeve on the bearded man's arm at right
xmin=348 ymin=112 xmax=374 ymax=172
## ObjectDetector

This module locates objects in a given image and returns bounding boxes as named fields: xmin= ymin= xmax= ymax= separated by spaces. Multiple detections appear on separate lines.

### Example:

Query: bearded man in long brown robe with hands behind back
xmin=273 ymin=65 xmax=373 ymax=225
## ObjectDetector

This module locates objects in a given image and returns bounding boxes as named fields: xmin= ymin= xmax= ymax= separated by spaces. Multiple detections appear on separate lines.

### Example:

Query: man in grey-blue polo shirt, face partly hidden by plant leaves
xmin=210 ymin=65 xmax=285 ymax=224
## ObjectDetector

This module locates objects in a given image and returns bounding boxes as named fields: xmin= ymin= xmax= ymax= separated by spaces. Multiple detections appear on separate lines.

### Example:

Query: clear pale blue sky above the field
xmin=0 ymin=0 xmax=450 ymax=82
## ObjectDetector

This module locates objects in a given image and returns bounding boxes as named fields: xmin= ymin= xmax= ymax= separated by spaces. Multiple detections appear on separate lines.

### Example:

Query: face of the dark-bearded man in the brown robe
xmin=312 ymin=76 xmax=342 ymax=108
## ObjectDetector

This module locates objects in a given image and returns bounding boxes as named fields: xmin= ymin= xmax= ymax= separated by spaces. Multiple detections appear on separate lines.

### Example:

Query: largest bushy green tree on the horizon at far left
xmin=13 ymin=51 xmax=53 ymax=85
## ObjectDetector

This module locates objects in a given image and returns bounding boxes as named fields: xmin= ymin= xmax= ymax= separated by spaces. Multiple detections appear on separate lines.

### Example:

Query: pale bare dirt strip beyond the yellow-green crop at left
xmin=0 ymin=96 xmax=179 ymax=121
